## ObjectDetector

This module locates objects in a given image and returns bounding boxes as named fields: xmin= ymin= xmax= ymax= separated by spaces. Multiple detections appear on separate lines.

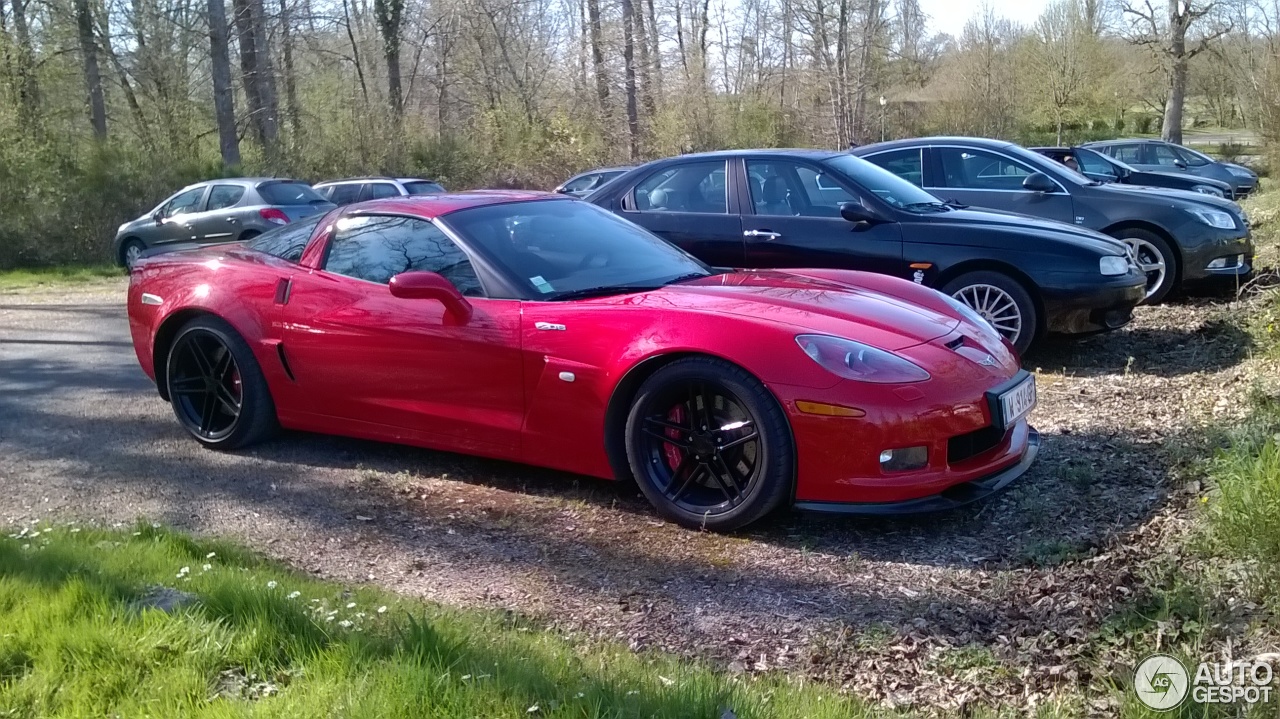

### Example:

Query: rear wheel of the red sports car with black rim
xmin=165 ymin=315 xmax=279 ymax=449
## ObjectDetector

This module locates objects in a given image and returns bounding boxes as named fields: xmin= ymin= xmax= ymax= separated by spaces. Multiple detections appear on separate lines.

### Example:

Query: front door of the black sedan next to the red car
xmin=735 ymin=152 xmax=919 ymax=278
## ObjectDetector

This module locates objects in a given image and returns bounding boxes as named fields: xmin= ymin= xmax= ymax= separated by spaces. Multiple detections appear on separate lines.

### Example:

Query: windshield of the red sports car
xmin=442 ymin=200 xmax=714 ymax=299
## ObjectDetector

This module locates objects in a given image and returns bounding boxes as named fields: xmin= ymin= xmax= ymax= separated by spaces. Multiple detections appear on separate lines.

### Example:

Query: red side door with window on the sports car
xmin=283 ymin=209 xmax=524 ymax=457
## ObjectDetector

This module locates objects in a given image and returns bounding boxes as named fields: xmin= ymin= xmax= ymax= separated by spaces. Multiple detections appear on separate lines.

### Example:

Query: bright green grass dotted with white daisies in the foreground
xmin=0 ymin=525 xmax=870 ymax=719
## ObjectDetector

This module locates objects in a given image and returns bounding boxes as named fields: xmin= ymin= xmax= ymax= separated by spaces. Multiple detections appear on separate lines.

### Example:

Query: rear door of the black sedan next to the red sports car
xmin=622 ymin=160 xmax=745 ymax=267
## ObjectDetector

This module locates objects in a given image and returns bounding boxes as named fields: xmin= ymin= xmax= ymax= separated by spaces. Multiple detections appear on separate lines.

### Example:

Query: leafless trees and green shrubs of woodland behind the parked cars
xmin=0 ymin=0 xmax=1280 ymax=263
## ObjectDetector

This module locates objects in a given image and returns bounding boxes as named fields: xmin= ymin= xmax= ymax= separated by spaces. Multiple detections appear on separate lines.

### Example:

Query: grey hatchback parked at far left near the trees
xmin=111 ymin=178 xmax=334 ymax=267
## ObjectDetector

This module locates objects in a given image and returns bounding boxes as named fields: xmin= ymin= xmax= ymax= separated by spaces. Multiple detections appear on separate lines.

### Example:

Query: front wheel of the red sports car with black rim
xmin=626 ymin=357 xmax=796 ymax=532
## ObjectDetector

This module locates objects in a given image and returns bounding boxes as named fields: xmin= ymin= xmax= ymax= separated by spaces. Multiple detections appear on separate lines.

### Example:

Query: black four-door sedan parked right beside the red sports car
xmin=586 ymin=150 xmax=1143 ymax=352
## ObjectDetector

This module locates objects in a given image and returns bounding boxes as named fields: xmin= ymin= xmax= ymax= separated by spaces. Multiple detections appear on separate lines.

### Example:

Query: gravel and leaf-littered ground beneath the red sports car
xmin=0 ymin=277 xmax=1251 ymax=704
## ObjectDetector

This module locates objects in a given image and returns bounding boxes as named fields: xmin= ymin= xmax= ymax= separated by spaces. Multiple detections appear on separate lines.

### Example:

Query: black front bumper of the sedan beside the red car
xmin=1041 ymin=274 xmax=1147 ymax=334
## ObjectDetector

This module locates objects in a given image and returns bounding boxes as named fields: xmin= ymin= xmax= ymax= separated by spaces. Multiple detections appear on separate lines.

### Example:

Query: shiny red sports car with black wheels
xmin=129 ymin=192 xmax=1038 ymax=530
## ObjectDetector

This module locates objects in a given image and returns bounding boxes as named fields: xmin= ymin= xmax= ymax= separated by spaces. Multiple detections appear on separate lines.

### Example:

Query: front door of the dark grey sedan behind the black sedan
xmin=924 ymin=145 xmax=1075 ymax=223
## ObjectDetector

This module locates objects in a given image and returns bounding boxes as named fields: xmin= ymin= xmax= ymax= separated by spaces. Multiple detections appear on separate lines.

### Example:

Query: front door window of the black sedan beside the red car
xmin=746 ymin=160 xmax=859 ymax=217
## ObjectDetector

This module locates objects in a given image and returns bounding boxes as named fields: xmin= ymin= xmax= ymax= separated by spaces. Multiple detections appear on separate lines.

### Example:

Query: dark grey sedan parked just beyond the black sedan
xmin=854 ymin=137 xmax=1253 ymax=303
